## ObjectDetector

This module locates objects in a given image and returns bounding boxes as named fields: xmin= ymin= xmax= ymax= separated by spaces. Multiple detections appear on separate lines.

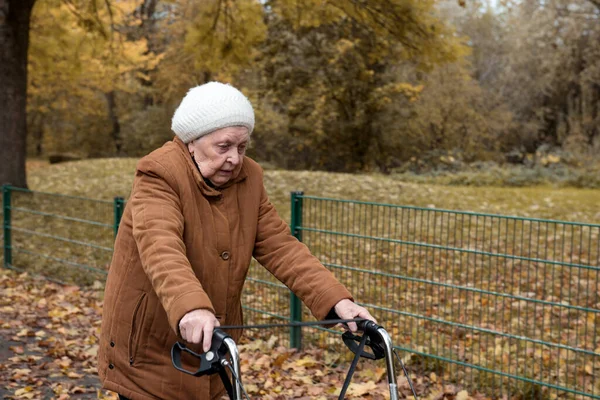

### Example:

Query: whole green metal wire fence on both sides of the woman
xmin=3 ymin=187 xmax=600 ymax=399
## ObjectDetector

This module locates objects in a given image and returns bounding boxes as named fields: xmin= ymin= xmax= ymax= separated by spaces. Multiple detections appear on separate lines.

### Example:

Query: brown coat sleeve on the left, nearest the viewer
xmin=130 ymin=159 xmax=215 ymax=334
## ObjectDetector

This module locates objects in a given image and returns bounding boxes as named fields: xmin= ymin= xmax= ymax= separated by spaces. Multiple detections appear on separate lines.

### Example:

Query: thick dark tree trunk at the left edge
xmin=0 ymin=0 xmax=35 ymax=188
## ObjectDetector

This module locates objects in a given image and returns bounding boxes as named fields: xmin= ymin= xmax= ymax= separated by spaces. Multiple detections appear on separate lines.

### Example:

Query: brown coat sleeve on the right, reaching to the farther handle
xmin=253 ymin=173 xmax=352 ymax=320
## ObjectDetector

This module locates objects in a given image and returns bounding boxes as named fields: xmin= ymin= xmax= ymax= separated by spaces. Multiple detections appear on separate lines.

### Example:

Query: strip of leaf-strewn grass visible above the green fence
xmin=21 ymin=158 xmax=600 ymax=223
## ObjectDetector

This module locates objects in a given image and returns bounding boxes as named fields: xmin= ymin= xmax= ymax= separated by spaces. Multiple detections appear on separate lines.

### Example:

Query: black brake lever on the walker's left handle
xmin=171 ymin=329 xmax=231 ymax=376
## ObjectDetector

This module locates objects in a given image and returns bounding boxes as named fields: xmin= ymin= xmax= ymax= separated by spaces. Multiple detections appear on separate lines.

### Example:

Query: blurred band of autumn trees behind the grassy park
xmin=5 ymin=0 xmax=600 ymax=178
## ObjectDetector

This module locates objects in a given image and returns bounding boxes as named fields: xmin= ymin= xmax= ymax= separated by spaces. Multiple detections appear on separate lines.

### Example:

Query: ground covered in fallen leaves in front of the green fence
xmin=0 ymin=270 xmax=486 ymax=400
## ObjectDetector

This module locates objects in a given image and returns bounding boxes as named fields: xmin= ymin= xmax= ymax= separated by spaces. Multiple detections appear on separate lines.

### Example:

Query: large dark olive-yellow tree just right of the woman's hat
xmin=255 ymin=0 xmax=466 ymax=171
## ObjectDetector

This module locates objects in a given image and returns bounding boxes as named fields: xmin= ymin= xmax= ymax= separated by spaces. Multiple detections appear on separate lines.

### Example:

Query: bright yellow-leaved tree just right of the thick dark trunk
xmin=27 ymin=0 xmax=164 ymax=157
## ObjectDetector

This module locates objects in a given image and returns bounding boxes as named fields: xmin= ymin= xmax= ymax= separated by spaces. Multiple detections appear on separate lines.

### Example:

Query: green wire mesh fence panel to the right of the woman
xmin=296 ymin=197 xmax=600 ymax=399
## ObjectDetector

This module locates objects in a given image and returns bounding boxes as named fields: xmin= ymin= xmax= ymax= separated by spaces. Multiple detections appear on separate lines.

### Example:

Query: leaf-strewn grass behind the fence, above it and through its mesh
xmin=1 ymin=158 xmax=600 ymax=397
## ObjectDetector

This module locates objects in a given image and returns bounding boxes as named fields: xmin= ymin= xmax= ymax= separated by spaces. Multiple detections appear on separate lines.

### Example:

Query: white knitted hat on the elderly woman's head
xmin=171 ymin=82 xmax=254 ymax=143
